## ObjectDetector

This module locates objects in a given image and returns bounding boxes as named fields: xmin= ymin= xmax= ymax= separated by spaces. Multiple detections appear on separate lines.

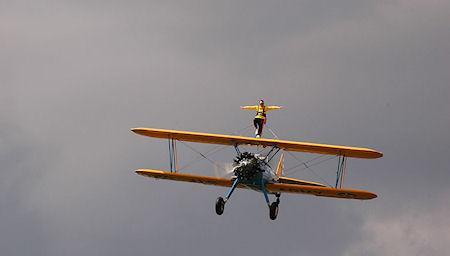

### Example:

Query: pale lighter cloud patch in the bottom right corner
xmin=343 ymin=192 xmax=450 ymax=256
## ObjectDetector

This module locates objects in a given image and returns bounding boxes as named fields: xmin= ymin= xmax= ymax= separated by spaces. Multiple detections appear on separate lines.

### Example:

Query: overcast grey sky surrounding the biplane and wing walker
xmin=0 ymin=0 xmax=450 ymax=256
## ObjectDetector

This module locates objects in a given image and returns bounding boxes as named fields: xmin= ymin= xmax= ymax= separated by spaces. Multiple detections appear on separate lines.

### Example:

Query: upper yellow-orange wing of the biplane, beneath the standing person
xmin=132 ymin=128 xmax=383 ymax=158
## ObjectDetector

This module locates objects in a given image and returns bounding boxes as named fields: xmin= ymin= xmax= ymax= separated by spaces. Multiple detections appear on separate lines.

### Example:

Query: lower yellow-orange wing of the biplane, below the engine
xmin=136 ymin=169 xmax=377 ymax=200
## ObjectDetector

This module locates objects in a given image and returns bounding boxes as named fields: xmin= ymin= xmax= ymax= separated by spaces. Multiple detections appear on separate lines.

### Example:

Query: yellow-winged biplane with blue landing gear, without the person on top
xmin=132 ymin=122 xmax=383 ymax=220
